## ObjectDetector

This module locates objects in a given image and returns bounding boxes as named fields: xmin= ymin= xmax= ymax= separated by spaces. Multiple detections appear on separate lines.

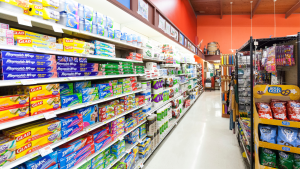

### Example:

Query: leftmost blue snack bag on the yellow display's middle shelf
xmin=258 ymin=125 xmax=277 ymax=144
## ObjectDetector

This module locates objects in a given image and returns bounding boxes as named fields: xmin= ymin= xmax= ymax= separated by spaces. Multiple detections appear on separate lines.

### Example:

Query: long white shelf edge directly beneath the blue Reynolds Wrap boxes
xmin=0 ymin=74 xmax=145 ymax=87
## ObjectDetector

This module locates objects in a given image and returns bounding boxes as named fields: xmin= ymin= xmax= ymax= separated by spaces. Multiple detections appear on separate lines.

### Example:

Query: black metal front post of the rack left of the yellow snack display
xmin=250 ymin=36 xmax=253 ymax=169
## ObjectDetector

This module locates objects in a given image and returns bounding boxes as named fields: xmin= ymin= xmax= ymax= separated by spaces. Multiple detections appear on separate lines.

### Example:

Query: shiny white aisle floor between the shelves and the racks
xmin=143 ymin=91 xmax=244 ymax=169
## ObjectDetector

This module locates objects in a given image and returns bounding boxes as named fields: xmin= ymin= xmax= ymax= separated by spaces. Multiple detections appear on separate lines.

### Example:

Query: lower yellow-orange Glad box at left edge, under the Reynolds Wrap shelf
xmin=0 ymin=105 xmax=29 ymax=123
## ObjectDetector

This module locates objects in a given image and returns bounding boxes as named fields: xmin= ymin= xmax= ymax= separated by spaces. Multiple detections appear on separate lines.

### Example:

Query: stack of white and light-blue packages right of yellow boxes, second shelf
xmin=92 ymin=40 xmax=116 ymax=57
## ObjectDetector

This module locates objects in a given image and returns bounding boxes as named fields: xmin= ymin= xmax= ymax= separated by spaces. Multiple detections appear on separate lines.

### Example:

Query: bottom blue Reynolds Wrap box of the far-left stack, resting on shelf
xmin=1 ymin=72 xmax=57 ymax=80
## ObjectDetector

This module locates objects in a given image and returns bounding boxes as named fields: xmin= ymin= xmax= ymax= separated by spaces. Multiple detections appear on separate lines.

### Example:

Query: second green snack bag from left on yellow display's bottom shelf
xmin=278 ymin=151 xmax=294 ymax=169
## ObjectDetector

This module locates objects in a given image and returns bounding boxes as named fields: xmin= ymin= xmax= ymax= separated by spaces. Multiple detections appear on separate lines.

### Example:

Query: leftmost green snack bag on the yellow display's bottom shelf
xmin=259 ymin=148 xmax=276 ymax=168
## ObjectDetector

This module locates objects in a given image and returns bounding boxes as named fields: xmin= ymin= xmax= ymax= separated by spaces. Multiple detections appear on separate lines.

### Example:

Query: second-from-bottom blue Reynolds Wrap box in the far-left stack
xmin=0 ymin=65 xmax=56 ymax=73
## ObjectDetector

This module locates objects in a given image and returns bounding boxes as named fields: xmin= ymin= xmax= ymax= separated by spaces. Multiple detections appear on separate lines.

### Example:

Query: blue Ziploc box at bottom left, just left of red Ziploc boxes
xmin=25 ymin=151 xmax=57 ymax=169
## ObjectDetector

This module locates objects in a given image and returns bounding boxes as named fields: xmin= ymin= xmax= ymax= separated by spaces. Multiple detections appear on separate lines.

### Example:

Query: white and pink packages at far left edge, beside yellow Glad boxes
xmin=0 ymin=23 xmax=14 ymax=45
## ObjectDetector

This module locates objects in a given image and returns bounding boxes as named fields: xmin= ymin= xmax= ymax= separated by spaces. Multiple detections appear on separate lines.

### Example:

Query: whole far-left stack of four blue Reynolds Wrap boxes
xmin=1 ymin=51 xmax=57 ymax=80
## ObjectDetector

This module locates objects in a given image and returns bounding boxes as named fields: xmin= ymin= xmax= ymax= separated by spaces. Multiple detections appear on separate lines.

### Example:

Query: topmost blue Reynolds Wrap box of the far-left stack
xmin=0 ymin=50 xmax=55 ymax=61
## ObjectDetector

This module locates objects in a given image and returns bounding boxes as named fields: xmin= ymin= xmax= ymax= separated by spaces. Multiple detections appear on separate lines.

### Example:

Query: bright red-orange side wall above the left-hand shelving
xmin=150 ymin=0 xmax=197 ymax=45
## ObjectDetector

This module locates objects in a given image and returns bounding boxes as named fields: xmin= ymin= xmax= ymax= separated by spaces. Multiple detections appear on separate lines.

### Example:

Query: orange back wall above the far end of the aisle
xmin=197 ymin=14 xmax=300 ymax=54
